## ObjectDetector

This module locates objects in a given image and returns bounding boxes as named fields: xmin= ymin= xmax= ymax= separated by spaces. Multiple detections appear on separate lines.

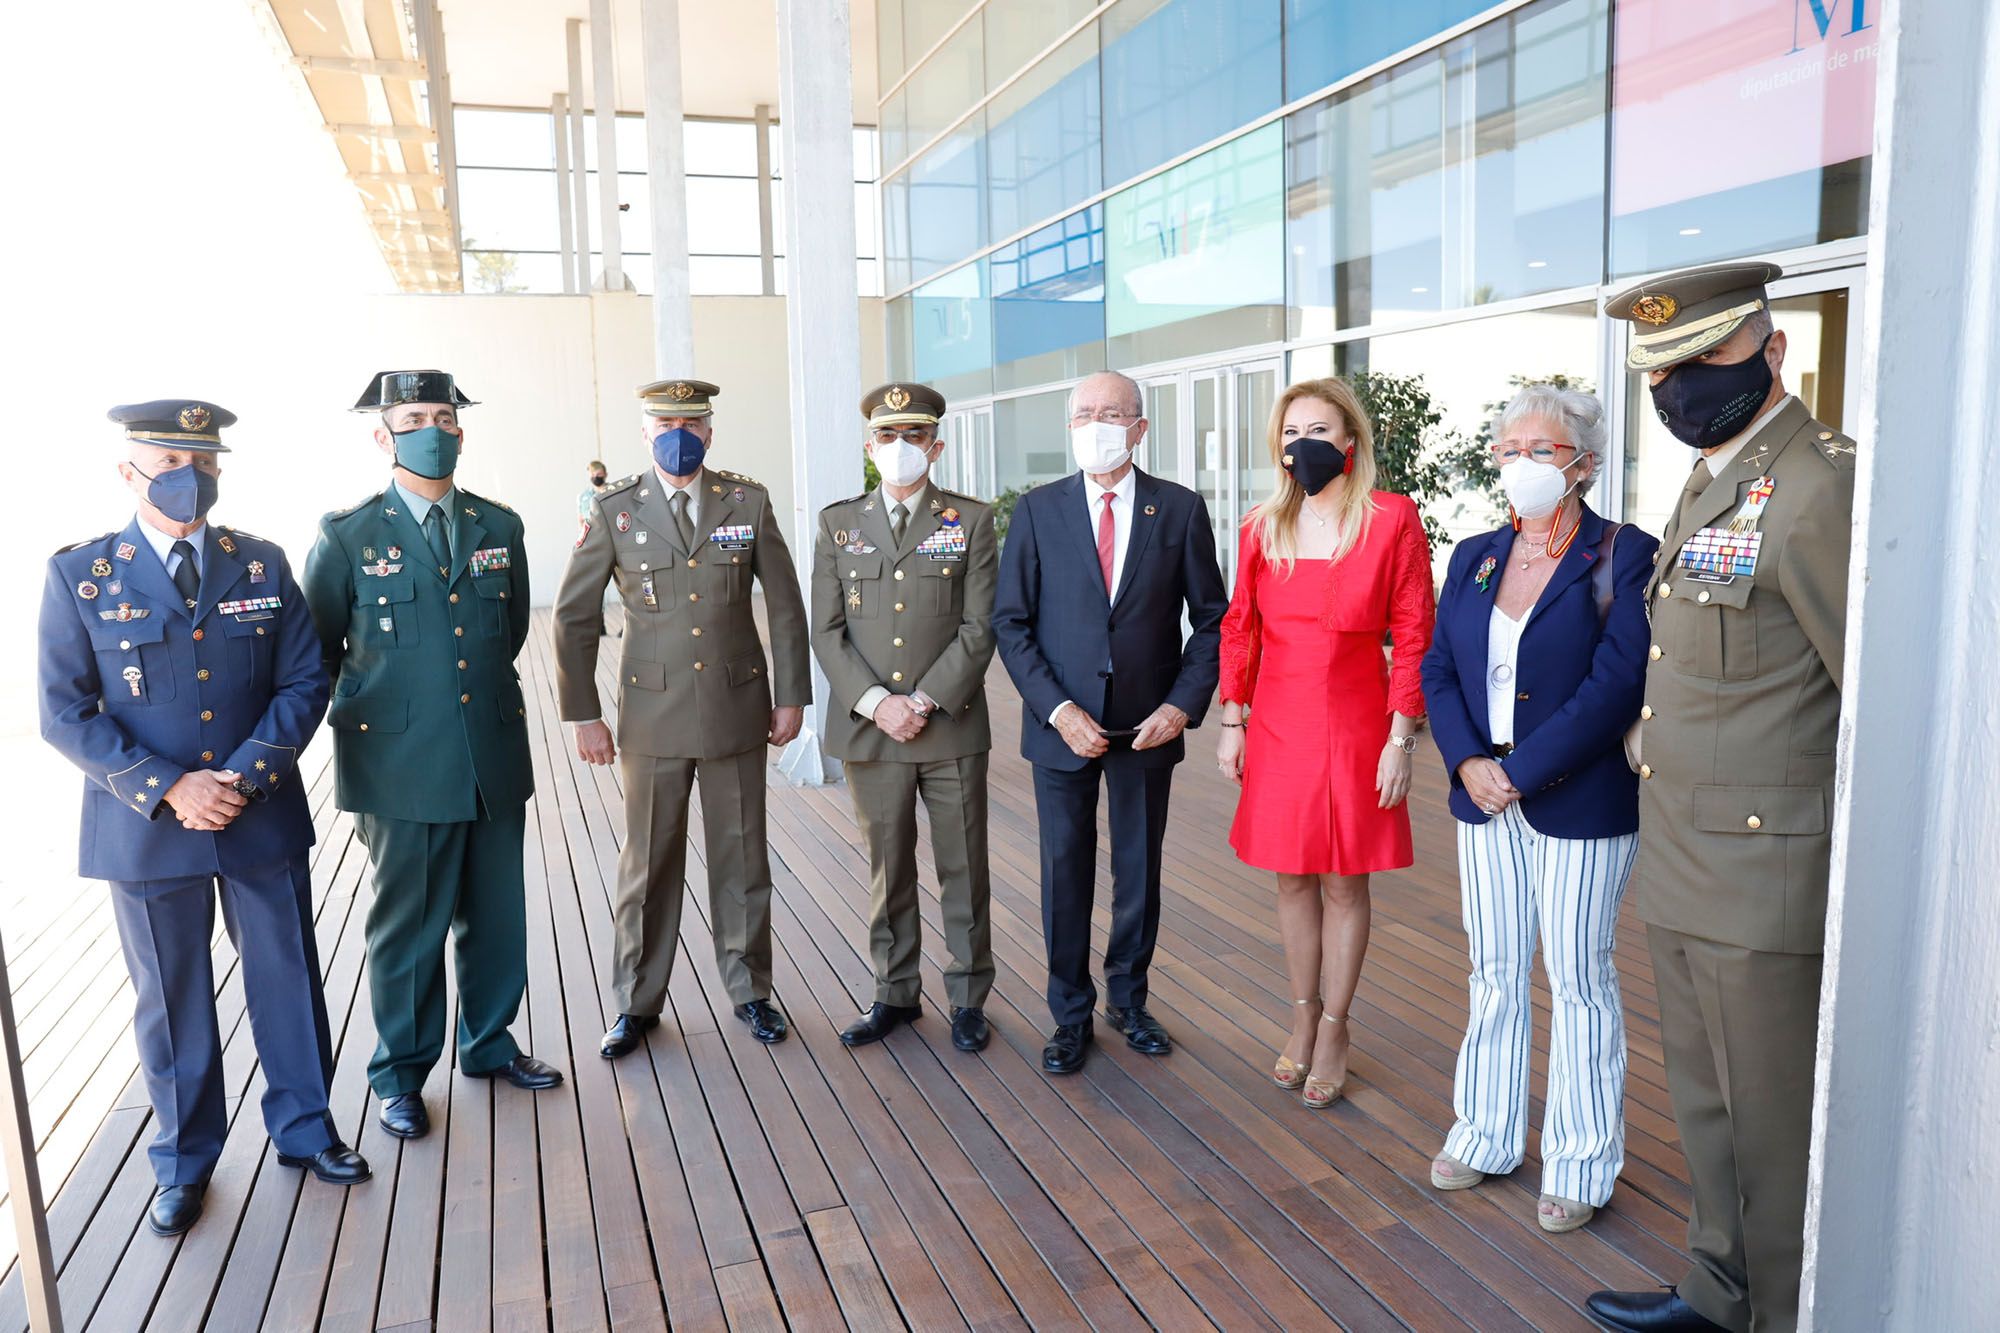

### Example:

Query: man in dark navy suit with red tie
xmin=994 ymin=372 xmax=1228 ymax=1073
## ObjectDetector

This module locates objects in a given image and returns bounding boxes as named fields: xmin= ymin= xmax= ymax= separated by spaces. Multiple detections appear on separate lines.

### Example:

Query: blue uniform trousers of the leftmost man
xmin=112 ymin=853 xmax=336 ymax=1185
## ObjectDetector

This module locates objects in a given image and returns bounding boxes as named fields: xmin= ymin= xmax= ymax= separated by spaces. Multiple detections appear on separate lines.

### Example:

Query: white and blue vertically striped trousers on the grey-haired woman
xmin=1444 ymin=803 xmax=1638 ymax=1207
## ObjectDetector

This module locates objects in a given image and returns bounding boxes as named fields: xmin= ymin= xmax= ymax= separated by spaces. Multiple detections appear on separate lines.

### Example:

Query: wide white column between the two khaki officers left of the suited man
xmin=776 ymin=0 xmax=866 ymax=783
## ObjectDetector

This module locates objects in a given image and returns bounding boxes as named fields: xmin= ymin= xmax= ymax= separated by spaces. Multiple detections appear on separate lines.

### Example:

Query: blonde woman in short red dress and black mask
xmin=1218 ymin=370 xmax=1436 ymax=1109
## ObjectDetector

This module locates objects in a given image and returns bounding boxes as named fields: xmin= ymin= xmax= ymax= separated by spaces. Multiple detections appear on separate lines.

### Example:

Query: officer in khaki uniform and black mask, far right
xmin=1590 ymin=264 xmax=1854 ymax=1331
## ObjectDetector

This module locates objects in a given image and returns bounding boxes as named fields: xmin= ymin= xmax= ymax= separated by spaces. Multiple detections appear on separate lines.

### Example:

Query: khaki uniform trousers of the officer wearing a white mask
xmin=846 ymin=755 xmax=994 ymax=1009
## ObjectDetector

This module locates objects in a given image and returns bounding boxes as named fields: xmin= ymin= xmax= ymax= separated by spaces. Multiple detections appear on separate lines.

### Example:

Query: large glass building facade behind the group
xmin=880 ymin=0 xmax=1898 ymax=564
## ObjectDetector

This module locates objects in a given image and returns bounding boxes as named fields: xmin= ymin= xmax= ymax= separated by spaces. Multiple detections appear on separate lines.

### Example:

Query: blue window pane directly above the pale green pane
xmin=1100 ymin=0 xmax=1284 ymax=184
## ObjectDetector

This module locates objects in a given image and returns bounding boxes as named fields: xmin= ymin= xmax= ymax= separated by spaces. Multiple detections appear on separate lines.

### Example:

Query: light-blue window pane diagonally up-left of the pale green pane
xmin=986 ymin=28 xmax=1104 ymax=238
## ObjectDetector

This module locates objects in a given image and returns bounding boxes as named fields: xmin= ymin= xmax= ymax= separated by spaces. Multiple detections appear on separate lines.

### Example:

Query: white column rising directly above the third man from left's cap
xmin=640 ymin=0 xmax=698 ymax=374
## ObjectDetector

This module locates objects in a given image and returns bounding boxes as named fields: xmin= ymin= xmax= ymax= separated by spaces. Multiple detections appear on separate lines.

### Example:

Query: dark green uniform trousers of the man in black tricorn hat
xmin=354 ymin=805 xmax=528 ymax=1097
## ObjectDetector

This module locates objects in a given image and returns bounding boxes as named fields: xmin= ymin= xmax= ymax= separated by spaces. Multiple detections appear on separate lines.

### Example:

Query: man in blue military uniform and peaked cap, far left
xmin=40 ymin=398 xmax=368 ymax=1235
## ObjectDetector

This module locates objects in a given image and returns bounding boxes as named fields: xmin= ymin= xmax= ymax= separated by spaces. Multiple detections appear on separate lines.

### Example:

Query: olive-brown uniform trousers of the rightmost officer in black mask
xmin=1646 ymin=925 xmax=1820 ymax=1333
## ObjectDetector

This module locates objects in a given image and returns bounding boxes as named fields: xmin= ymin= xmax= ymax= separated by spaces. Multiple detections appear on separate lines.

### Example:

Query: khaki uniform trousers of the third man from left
xmin=612 ymin=745 xmax=770 ymax=1017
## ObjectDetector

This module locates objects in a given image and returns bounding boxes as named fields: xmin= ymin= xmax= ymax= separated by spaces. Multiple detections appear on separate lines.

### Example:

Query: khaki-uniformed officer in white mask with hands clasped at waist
xmin=812 ymin=384 xmax=1000 ymax=1051
